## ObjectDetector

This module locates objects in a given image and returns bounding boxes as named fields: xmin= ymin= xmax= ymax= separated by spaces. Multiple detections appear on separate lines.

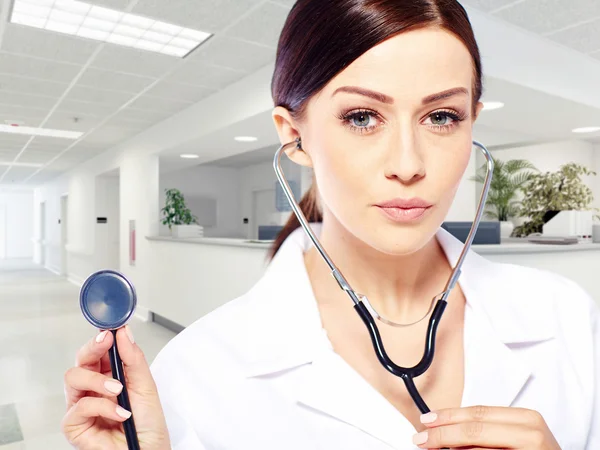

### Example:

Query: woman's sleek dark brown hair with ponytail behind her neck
xmin=271 ymin=0 xmax=483 ymax=256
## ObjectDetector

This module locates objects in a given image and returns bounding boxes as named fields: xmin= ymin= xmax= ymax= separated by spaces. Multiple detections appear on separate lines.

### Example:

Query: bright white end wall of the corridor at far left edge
xmin=0 ymin=191 xmax=33 ymax=258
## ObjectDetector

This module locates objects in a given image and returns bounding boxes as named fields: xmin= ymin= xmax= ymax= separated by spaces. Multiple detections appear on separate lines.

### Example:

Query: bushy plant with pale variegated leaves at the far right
xmin=512 ymin=163 xmax=598 ymax=237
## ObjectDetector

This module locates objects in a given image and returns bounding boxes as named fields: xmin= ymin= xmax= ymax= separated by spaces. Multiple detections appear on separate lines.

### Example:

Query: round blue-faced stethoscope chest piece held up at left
xmin=79 ymin=270 xmax=137 ymax=330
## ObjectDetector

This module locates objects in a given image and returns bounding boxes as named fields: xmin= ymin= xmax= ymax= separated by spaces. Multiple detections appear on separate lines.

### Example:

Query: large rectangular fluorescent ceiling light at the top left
xmin=10 ymin=0 xmax=211 ymax=58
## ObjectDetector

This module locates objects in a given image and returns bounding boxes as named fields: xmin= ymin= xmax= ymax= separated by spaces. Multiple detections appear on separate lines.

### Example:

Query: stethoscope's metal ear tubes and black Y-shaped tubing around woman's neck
xmin=273 ymin=138 xmax=494 ymax=414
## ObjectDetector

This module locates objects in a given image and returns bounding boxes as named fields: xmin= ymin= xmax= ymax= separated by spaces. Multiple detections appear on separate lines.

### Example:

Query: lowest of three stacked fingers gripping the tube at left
xmin=62 ymin=397 xmax=131 ymax=436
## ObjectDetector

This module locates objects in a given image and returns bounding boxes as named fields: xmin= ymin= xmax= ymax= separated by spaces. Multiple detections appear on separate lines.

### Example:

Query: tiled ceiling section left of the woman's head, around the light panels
xmin=0 ymin=0 xmax=293 ymax=185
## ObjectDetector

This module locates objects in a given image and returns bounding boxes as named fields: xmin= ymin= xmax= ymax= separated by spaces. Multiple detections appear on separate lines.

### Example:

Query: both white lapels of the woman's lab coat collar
xmin=238 ymin=224 xmax=553 ymax=448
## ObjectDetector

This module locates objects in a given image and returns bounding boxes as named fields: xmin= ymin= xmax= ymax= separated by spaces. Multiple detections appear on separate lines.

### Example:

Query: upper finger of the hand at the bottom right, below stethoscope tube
xmin=421 ymin=406 xmax=544 ymax=428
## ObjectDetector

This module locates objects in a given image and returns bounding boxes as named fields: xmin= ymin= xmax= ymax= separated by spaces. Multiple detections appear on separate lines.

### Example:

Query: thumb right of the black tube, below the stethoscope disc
xmin=116 ymin=325 xmax=156 ymax=393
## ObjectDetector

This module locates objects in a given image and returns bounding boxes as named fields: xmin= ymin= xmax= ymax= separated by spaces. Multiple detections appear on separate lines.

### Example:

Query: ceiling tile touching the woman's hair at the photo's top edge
xmin=225 ymin=3 xmax=289 ymax=47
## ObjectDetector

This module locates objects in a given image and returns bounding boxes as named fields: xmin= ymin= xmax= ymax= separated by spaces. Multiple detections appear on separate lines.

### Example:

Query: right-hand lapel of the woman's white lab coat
xmin=437 ymin=229 xmax=554 ymax=406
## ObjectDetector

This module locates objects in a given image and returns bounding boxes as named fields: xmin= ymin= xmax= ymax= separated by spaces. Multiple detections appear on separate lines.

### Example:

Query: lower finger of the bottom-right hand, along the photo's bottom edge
xmin=413 ymin=422 xmax=534 ymax=449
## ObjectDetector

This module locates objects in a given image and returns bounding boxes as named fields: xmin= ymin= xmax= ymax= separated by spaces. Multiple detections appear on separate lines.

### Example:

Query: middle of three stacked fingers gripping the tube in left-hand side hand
xmin=65 ymin=367 xmax=123 ymax=409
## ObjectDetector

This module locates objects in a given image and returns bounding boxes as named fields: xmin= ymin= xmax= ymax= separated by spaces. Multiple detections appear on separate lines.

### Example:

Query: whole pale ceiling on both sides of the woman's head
xmin=0 ymin=0 xmax=600 ymax=186
